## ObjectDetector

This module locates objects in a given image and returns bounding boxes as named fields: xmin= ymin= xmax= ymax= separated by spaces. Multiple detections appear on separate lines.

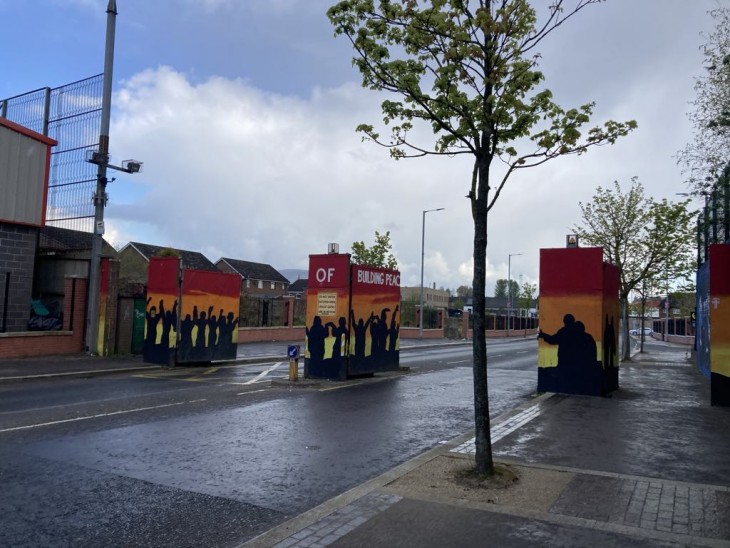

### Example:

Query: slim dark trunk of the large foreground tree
xmin=471 ymin=157 xmax=494 ymax=474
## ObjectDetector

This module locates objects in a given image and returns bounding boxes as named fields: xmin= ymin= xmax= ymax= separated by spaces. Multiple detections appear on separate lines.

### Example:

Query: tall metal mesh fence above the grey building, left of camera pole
xmin=0 ymin=74 xmax=104 ymax=238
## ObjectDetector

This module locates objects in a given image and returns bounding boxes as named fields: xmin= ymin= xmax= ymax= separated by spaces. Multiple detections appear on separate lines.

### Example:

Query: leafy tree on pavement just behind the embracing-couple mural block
xmin=574 ymin=177 xmax=695 ymax=361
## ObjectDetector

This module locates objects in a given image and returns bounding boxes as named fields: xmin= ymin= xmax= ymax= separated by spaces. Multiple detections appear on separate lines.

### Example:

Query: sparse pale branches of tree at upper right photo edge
xmin=677 ymin=7 xmax=730 ymax=194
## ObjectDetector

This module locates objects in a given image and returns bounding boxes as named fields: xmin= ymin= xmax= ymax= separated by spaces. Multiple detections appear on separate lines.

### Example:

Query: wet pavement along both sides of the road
xmin=0 ymin=341 xmax=730 ymax=548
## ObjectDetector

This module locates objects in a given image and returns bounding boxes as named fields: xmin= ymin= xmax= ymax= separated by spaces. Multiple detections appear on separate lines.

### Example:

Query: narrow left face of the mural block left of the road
xmin=142 ymin=257 xmax=180 ymax=365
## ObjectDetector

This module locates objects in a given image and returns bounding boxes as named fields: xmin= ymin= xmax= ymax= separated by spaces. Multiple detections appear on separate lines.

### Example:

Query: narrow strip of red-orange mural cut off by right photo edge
xmin=709 ymin=244 xmax=730 ymax=406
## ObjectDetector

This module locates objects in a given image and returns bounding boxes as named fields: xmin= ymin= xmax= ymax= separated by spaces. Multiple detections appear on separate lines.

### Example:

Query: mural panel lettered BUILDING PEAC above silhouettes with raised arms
xmin=349 ymin=265 xmax=400 ymax=375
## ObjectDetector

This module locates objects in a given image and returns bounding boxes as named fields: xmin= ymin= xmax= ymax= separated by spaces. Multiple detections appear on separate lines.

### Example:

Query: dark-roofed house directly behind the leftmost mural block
xmin=119 ymin=242 xmax=218 ymax=296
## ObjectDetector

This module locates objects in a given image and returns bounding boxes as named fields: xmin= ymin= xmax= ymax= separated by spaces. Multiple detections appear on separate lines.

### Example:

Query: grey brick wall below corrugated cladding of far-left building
xmin=0 ymin=223 xmax=38 ymax=332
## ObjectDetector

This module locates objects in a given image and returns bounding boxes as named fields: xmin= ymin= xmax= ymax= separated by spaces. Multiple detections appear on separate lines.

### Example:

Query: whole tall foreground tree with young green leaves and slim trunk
xmin=327 ymin=0 xmax=636 ymax=474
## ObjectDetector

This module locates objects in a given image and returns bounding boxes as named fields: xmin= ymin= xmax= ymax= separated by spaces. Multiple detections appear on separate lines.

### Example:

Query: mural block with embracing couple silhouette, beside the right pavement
xmin=538 ymin=248 xmax=618 ymax=395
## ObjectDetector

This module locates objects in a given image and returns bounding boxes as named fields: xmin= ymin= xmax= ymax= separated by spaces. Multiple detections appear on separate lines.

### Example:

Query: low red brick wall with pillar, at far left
xmin=0 ymin=278 xmax=86 ymax=359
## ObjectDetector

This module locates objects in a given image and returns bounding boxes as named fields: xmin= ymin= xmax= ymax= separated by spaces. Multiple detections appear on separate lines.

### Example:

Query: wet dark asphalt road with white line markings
xmin=0 ymin=341 xmax=536 ymax=546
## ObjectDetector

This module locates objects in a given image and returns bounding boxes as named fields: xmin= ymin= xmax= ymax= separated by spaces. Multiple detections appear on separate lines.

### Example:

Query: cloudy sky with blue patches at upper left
xmin=0 ymin=0 xmax=730 ymax=295
